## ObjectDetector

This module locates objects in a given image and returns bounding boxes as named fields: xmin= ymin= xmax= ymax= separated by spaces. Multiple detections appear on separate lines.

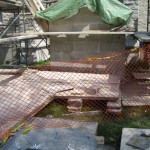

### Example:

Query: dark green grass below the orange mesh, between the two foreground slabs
xmin=97 ymin=115 xmax=150 ymax=144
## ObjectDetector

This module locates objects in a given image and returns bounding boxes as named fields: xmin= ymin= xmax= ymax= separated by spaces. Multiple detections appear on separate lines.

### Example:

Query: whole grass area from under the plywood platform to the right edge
xmin=37 ymin=101 xmax=150 ymax=146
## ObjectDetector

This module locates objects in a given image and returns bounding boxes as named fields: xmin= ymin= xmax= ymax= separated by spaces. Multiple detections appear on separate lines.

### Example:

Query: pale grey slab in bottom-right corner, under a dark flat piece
xmin=120 ymin=128 xmax=150 ymax=150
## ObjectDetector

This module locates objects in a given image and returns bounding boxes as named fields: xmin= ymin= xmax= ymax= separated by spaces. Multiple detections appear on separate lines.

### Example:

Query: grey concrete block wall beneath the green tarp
xmin=49 ymin=8 xmax=125 ymax=61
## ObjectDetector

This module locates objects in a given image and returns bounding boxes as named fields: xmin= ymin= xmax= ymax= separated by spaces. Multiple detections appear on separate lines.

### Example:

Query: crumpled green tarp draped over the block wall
xmin=36 ymin=0 xmax=133 ymax=26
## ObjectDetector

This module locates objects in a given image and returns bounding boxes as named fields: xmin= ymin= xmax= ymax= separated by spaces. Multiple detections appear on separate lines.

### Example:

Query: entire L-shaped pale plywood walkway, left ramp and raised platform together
xmin=0 ymin=70 xmax=120 ymax=137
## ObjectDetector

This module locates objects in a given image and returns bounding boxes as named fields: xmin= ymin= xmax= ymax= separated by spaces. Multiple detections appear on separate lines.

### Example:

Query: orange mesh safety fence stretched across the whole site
xmin=0 ymin=47 xmax=150 ymax=145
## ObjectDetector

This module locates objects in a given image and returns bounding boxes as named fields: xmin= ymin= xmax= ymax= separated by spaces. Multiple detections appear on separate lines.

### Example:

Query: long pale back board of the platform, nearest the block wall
xmin=36 ymin=71 xmax=120 ymax=84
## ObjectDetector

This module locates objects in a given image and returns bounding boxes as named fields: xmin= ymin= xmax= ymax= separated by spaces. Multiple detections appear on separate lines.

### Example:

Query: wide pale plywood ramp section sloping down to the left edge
xmin=0 ymin=71 xmax=75 ymax=138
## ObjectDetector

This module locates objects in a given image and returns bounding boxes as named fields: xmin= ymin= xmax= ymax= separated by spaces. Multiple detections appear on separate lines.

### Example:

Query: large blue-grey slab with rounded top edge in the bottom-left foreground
xmin=2 ymin=128 xmax=97 ymax=150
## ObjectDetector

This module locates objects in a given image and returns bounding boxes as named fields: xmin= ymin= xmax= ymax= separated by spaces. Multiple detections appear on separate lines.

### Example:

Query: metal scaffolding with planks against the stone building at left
xmin=0 ymin=0 xmax=50 ymax=65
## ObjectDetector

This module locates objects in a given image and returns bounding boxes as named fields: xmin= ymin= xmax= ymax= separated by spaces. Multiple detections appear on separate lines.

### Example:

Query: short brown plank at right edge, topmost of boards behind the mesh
xmin=133 ymin=72 xmax=150 ymax=80
